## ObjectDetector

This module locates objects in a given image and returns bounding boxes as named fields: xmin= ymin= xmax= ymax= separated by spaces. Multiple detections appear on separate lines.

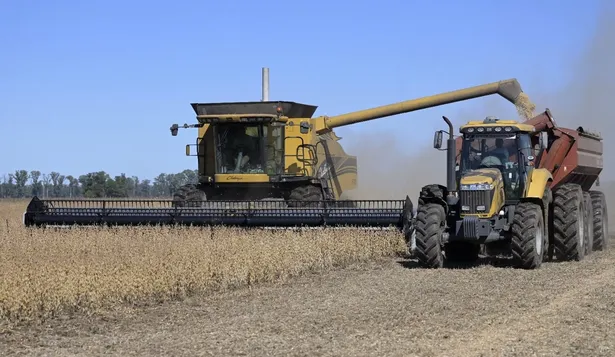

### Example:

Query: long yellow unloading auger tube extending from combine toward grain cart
xmin=319 ymin=78 xmax=523 ymax=132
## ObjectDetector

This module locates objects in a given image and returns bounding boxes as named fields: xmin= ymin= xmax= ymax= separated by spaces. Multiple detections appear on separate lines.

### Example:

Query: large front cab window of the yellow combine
xmin=216 ymin=123 xmax=283 ymax=175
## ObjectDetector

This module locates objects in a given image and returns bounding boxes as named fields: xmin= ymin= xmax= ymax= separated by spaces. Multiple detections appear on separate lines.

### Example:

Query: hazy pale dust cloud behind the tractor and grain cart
xmin=347 ymin=3 xmax=615 ymax=211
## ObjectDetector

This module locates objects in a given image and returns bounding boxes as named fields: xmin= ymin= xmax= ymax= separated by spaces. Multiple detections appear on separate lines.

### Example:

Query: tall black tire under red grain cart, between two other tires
xmin=553 ymin=183 xmax=586 ymax=261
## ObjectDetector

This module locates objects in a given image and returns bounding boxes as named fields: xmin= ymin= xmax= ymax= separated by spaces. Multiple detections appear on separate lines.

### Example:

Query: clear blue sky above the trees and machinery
xmin=0 ymin=0 xmax=598 ymax=178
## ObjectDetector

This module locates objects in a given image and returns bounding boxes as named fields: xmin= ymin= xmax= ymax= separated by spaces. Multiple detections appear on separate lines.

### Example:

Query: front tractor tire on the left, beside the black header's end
xmin=415 ymin=203 xmax=445 ymax=268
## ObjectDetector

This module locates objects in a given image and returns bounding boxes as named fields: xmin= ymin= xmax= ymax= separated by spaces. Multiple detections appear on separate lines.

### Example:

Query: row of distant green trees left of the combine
xmin=0 ymin=170 xmax=198 ymax=198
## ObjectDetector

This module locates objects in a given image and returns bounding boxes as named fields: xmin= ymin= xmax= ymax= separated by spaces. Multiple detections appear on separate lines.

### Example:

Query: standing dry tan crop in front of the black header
xmin=0 ymin=201 xmax=406 ymax=324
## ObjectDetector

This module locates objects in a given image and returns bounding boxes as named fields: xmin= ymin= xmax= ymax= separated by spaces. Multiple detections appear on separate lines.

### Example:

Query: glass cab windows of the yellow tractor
xmin=460 ymin=134 xmax=525 ymax=200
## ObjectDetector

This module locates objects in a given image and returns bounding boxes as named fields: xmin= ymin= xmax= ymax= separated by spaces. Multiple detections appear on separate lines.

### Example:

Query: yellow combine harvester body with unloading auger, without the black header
xmin=171 ymin=69 xmax=521 ymax=207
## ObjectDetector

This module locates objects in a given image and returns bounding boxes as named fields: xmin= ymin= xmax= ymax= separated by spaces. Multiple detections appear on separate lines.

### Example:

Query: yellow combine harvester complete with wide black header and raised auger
xmin=24 ymin=69 xmax=536 ymax=237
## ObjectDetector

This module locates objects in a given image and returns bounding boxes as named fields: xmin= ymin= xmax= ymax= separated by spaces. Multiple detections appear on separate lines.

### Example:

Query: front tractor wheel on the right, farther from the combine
xmin=511 ymin=202 xmax=547 ymax=269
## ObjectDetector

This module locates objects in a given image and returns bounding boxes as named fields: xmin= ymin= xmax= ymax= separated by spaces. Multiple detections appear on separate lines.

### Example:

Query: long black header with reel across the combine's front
xmin=24 ymin=197 xmax=412 ymax=231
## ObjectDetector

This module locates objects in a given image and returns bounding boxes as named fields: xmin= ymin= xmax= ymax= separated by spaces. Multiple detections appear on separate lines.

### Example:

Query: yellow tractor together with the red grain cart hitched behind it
xmin=414 ymin=109 xmax=608 ymax=269
